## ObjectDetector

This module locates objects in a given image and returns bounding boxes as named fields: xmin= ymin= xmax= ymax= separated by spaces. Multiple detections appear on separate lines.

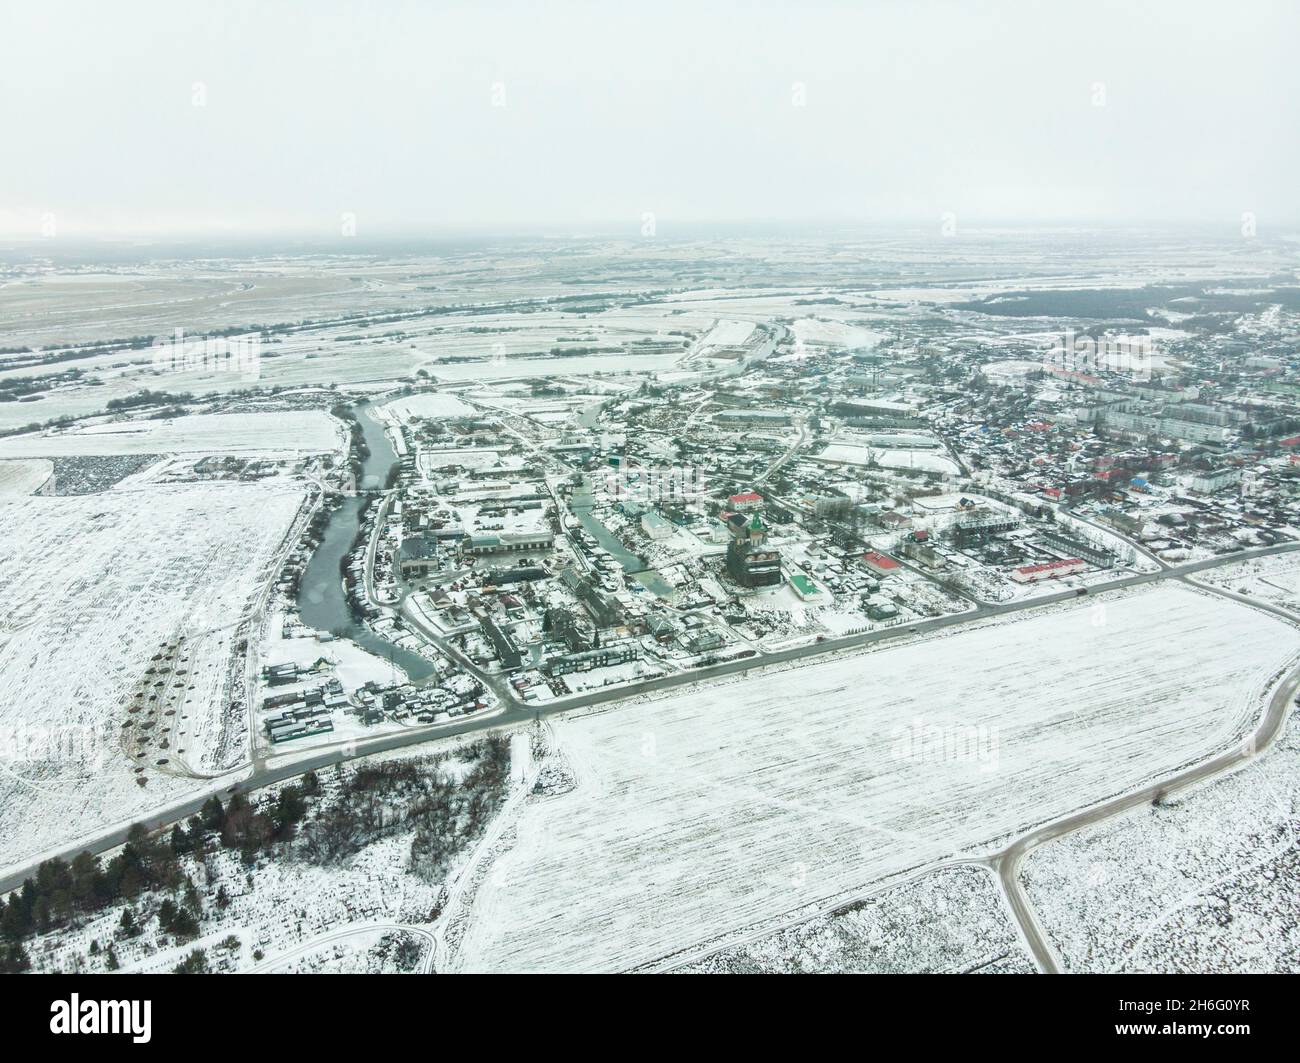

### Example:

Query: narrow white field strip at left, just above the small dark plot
xmin=0 ymin=409 xmax=343 ymax=457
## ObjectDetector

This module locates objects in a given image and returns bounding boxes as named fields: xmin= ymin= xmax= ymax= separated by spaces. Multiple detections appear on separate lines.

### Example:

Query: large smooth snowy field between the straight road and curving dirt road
xmin=451 ymin=587 xmax=1297 ymax=971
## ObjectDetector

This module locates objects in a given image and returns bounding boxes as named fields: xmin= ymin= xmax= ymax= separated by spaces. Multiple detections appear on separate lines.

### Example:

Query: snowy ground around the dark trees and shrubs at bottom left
xmin=20 ymin=737 xmax=517 ymax=972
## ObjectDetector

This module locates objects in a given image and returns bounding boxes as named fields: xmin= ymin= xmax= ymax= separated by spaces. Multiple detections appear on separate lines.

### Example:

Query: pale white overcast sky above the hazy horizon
xmin=0 ymin=0 xmax=1300 ymax=238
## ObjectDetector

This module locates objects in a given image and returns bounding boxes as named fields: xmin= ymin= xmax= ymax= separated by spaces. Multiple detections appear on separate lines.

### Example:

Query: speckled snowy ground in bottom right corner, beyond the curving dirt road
xmin=1021 ymin=701 xmax=1300 ymax=972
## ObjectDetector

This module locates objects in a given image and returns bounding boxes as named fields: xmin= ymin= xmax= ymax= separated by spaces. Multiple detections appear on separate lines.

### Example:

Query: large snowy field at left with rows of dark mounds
xmin=0 ymin=483 xmax=303 ymax=865
